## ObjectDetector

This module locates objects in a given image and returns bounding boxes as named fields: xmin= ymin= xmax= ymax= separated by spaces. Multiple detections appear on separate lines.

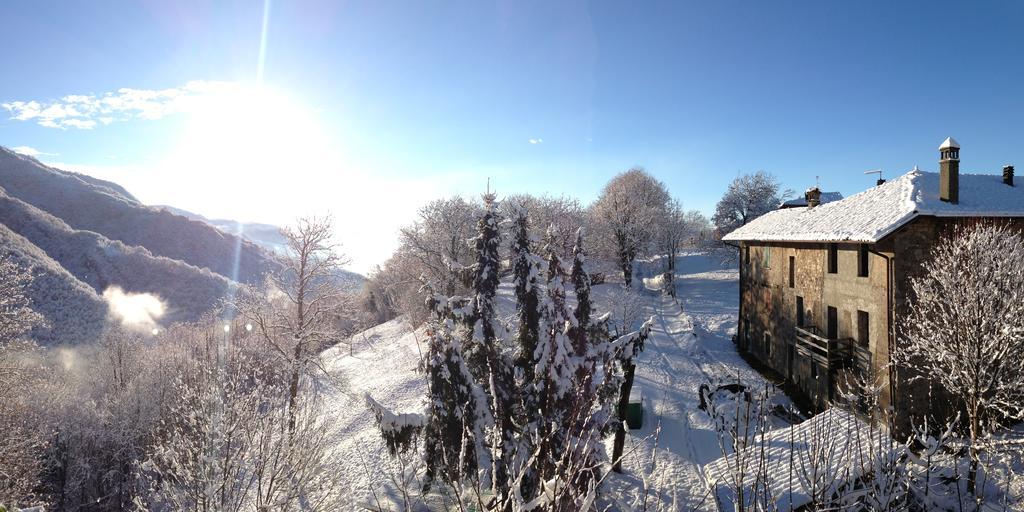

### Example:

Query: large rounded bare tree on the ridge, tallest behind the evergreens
xmin=589 ymin=168 xmax=670 ymax=286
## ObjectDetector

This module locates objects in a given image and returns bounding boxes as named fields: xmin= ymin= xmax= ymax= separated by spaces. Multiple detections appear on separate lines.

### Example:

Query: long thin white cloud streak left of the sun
xmin=0 ymin=80 xmax=235 ymax=130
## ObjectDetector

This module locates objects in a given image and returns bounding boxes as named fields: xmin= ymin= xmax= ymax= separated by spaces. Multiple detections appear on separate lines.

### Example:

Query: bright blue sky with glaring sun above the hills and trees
xmin=0 ymin=0 xmax=1024 ymax=269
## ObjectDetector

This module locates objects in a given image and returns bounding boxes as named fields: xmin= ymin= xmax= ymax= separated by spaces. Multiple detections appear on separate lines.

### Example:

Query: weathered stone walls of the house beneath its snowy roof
xmin=737 ymin=216 xmax=1024 ymax=429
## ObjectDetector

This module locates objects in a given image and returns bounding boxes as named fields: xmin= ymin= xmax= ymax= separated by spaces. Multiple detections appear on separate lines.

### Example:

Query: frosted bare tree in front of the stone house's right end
xmin=893 ymin=224 xmax=1024 ymax=496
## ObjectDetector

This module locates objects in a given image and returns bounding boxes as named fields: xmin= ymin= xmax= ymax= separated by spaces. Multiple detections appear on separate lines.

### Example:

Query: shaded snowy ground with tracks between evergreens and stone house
xmin=611 ymin=253 xmax=787 ymax=510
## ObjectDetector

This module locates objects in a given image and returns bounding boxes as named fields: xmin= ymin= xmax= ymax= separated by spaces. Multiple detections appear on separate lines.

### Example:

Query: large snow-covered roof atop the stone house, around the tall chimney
xmin=722 ymin=165 xmax=1024 ymax=243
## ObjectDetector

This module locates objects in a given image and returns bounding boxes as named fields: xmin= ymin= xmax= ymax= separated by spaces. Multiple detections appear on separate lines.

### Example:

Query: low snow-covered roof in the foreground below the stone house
xmin=703 ymin=409 xmax=880 ymax=510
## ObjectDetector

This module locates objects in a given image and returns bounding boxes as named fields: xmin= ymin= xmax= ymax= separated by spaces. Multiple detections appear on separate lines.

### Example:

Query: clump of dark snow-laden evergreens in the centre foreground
xmin=367 ymin=195 xmax=646 ymax=511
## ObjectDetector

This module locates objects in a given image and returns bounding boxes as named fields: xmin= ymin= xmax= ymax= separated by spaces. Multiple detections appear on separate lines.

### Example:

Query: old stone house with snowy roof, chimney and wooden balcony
xmin=723 ymin=138 xmax=1024 ymax=428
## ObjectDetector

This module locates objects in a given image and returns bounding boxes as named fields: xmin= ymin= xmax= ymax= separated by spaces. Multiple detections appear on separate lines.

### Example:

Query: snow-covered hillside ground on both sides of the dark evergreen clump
xmin=325 ymin=253 xmax=785 ymax=510
